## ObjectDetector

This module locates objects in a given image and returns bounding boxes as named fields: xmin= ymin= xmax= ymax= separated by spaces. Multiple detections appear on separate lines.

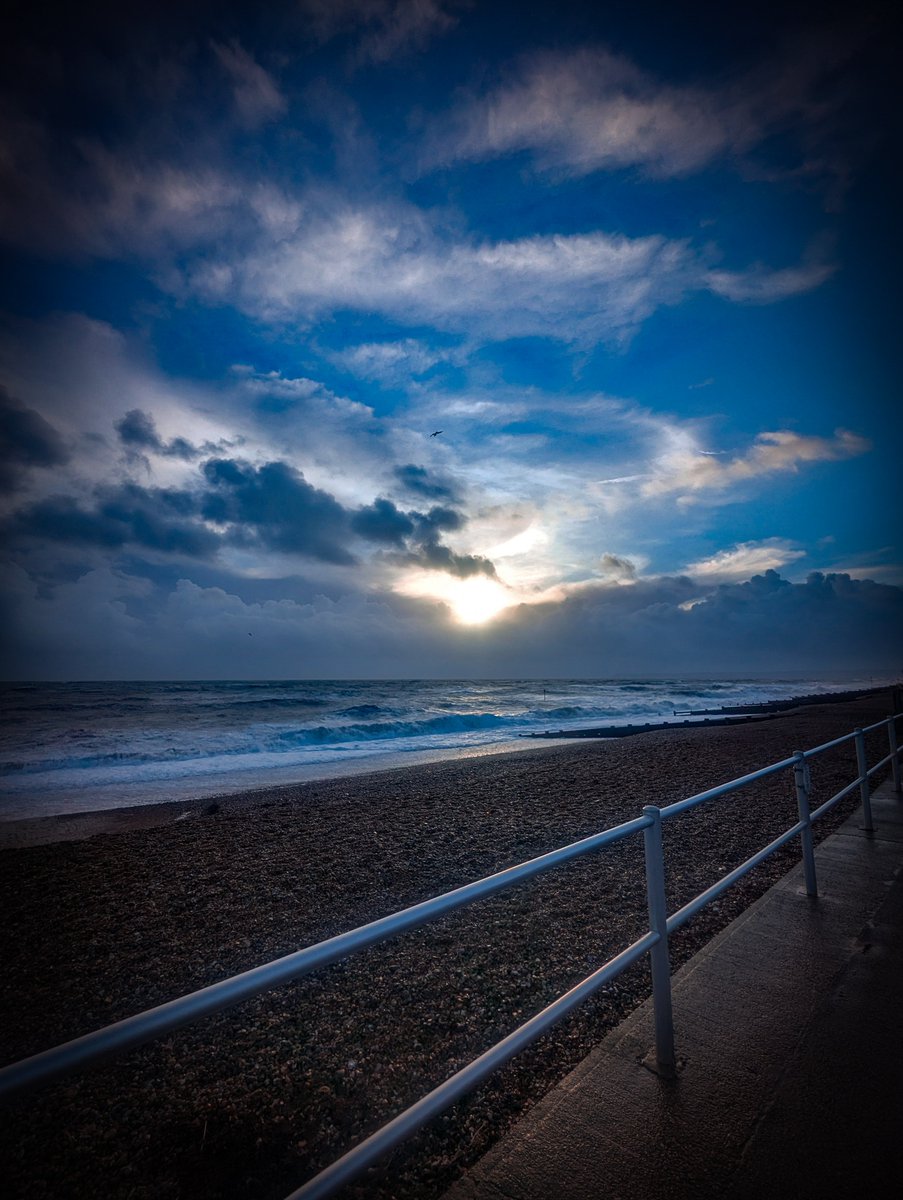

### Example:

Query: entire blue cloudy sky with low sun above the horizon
xmin=0 ymin=0 xmax=903 ymax=679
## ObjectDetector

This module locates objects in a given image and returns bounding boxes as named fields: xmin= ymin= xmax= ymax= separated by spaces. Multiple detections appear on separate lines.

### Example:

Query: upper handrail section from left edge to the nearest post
xmin=0 ymin=817 xmax=651 ymax=1097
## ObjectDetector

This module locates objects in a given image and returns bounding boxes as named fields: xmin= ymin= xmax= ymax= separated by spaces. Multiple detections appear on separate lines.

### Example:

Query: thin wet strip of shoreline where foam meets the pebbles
xmin=0 ymin=688 xmax=893 ymax=851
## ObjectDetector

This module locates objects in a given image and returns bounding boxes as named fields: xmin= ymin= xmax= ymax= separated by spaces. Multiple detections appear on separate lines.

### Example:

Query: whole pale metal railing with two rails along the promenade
xmin=0 ymin=713 xmax=903 ymax=1200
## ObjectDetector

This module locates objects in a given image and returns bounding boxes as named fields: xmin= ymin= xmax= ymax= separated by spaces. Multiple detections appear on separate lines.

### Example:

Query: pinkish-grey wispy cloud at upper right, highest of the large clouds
xmin=420 ymin=23 xmax=861 ymax=178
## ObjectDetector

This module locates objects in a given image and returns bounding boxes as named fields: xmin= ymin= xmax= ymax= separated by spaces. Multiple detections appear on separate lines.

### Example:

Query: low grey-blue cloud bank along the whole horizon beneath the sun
xmin=6 ymin=568 xmax=903 ymax=681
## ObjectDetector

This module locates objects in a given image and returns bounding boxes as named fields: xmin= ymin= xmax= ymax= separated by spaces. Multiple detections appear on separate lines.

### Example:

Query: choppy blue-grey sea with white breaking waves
xmin=0 ymin=679 xmax=875 ymax=821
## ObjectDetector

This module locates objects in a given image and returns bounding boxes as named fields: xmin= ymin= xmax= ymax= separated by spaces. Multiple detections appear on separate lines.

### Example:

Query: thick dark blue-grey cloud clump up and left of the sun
xmin=202 ymin=458 xmax=354 ymax=564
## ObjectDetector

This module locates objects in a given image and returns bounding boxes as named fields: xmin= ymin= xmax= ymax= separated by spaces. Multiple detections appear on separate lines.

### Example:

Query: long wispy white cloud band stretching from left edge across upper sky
xmin=0 ymin=106 xmax=832 ymax=346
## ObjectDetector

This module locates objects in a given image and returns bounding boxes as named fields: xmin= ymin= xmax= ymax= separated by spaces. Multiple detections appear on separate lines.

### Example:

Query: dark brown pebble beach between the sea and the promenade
xmin=0 ymin=691 xmax=891 ymax=1200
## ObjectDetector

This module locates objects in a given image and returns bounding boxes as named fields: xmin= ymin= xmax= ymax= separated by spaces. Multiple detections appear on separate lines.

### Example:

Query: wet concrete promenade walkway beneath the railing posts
xmin=445 ymin=782 xmax=903 ymax=1200
